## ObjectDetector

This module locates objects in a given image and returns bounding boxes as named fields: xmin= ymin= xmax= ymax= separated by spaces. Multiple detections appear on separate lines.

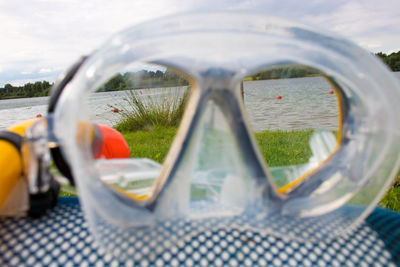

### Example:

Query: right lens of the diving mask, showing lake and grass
xmin=243 ymin=65 xmax=340 ymax=191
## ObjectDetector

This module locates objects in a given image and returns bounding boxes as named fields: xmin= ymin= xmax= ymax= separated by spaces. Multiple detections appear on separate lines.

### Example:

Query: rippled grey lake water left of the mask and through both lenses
xmin=0 ymin=77 xmax=337 ymax=131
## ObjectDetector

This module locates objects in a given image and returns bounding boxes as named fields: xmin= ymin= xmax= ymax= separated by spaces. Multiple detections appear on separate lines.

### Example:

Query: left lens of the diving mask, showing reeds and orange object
xmin=86 ymin=64 xmax=191 ymax=200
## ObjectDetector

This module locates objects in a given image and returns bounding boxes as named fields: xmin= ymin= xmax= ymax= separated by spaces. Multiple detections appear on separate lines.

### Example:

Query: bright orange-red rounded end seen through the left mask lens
xmin=92 ymin=123 xmax=130 ymax=159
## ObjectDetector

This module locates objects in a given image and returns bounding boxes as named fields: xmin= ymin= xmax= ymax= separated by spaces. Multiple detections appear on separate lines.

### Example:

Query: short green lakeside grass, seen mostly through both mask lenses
xmin=62 ymin=126 xmax=400 ymax=212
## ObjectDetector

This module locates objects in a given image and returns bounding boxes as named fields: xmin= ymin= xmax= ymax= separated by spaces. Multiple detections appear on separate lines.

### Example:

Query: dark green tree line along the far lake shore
xmin=0 ymin=51 xmax=400 ymax=99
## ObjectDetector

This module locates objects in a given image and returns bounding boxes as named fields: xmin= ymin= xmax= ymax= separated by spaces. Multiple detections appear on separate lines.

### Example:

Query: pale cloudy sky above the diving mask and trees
xmin=0 ymin=0 xmax=400 ymax=87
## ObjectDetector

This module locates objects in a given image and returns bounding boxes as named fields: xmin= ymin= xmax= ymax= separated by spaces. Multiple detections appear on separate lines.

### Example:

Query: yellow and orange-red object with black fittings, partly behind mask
xmin=0 ymin=119 xmax=130 ymax=217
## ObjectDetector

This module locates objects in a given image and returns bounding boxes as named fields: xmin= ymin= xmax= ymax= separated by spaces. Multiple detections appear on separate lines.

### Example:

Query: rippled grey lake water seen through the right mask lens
xmin=244 ymin=77 xmax=338 ymax=132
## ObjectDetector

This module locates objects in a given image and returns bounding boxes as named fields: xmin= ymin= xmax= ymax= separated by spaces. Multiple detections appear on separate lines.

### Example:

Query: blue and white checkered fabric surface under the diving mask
xmin=0 ymin=198 xmax=400 ymax=267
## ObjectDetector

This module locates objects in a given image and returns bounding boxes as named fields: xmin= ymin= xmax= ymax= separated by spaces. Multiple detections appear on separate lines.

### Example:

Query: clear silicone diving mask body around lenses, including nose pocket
xmin=50 ymin=13 xmax=400 ymax=256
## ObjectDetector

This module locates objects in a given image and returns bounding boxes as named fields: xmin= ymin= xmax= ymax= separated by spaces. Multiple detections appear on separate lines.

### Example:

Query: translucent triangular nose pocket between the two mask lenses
xmin=153 ymin=89 xmax=280 ymax=220
